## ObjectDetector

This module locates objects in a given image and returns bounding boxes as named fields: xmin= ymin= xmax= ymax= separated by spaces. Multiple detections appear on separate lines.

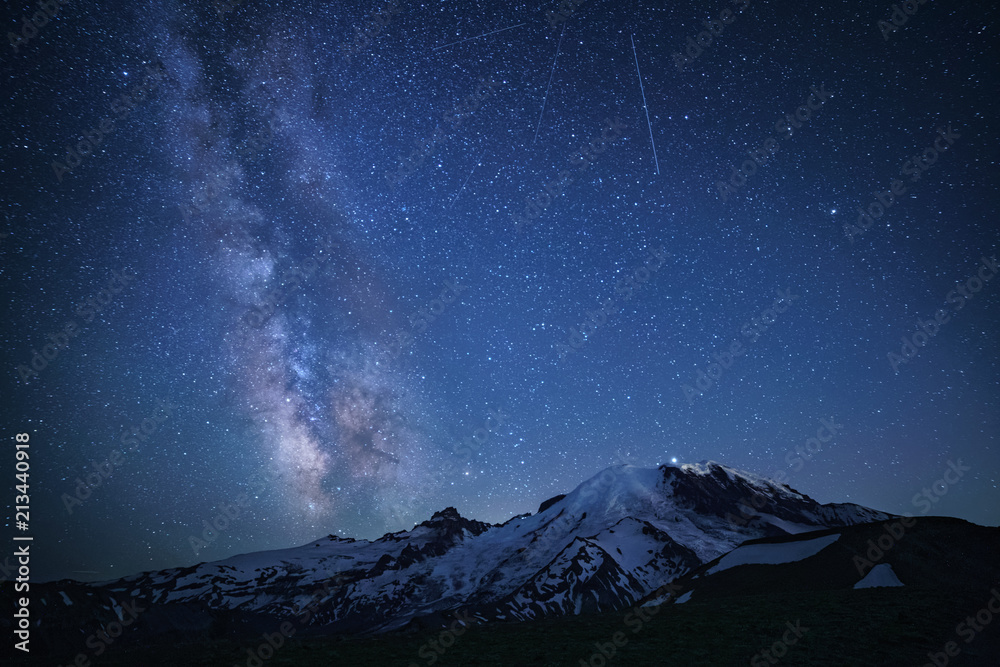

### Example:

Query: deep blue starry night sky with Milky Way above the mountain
xmin=0 ymin=0 xmax=1000 ymax=580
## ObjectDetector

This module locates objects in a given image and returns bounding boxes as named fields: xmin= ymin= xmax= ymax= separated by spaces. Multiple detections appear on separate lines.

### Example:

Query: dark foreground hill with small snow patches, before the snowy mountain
xmin=82 ymin=517 xmax=1000 ymax=667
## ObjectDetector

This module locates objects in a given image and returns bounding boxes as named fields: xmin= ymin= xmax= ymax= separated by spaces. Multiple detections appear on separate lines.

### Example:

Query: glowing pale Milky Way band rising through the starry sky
xmin=166 ymin=34 xmax=440 ymax=525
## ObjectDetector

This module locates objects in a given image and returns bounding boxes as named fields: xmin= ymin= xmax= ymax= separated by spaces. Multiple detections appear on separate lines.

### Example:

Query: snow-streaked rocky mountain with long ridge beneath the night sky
xmin=0 ymin=462 xmax=893 ymax=658
